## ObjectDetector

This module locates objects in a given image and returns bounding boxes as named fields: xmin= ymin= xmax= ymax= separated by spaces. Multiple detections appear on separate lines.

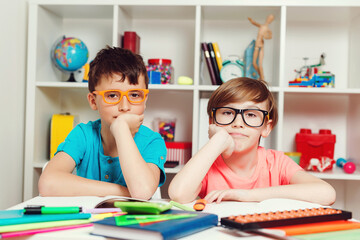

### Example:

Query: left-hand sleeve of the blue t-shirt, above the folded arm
xmin=55 ymin=125 xmax=86 ymax=165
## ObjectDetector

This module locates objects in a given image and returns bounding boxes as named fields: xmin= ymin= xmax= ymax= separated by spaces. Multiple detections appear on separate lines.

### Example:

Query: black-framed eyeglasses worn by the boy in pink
xmin=212 ymin=107 xmax=269 ymax=127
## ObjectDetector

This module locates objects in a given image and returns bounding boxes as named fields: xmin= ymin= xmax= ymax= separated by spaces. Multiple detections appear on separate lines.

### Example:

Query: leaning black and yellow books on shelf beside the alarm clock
xmin=201 ymin=42 xmax=222 ymax=85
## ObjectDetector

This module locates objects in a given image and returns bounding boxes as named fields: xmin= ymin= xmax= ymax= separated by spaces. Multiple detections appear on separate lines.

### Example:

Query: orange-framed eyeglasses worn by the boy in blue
xmin=92 ymin=89 xmax=149 ymax=104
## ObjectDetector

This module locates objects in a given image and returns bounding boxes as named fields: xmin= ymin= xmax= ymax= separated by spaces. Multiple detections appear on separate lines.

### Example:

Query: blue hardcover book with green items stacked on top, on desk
xmin=92 ymin=202 xmax=218 ymax=240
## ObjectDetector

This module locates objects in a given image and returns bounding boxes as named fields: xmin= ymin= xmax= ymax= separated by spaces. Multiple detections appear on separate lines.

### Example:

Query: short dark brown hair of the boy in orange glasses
xmin=88 ymin=46 xmax=149 ymax=92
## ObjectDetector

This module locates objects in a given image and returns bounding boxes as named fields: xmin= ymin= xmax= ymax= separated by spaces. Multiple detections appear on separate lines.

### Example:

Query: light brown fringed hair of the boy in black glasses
xmin=207 ymin=77 xmax=278 ymax=128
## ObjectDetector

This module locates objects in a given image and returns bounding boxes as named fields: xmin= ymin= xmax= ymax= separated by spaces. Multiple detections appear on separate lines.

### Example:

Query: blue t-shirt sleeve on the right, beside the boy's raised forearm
xmin=141 ymin=133 xmax=167 ymax=187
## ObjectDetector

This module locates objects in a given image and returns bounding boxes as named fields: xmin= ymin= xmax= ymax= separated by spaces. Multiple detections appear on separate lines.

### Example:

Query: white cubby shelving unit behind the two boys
xmin=24 ymin=0 xmax=360 ymax=216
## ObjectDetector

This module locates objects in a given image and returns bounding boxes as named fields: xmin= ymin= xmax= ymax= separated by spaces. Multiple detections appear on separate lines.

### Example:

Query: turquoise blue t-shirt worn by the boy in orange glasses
xmin=55 ymin=119 xmax=166 ymax=187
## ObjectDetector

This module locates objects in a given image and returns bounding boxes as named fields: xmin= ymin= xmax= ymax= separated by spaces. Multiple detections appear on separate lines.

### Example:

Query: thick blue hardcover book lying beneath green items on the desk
xmin=92 ymin=210 xmax=218 ymax=239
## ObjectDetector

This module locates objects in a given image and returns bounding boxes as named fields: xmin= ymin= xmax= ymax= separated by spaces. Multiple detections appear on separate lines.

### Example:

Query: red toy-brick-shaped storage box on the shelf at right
xmin=295 ymin=128 xmax=336 ymax=169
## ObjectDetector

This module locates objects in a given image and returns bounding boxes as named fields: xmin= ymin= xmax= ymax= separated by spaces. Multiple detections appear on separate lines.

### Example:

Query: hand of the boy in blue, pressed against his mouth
xmin=110 ymin=113 xmax=144 ymax=136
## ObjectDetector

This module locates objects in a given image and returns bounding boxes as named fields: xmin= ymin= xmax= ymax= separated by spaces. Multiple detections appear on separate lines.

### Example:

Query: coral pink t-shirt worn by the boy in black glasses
xmin=199 ymin=147 xmax=303 ymax=198
